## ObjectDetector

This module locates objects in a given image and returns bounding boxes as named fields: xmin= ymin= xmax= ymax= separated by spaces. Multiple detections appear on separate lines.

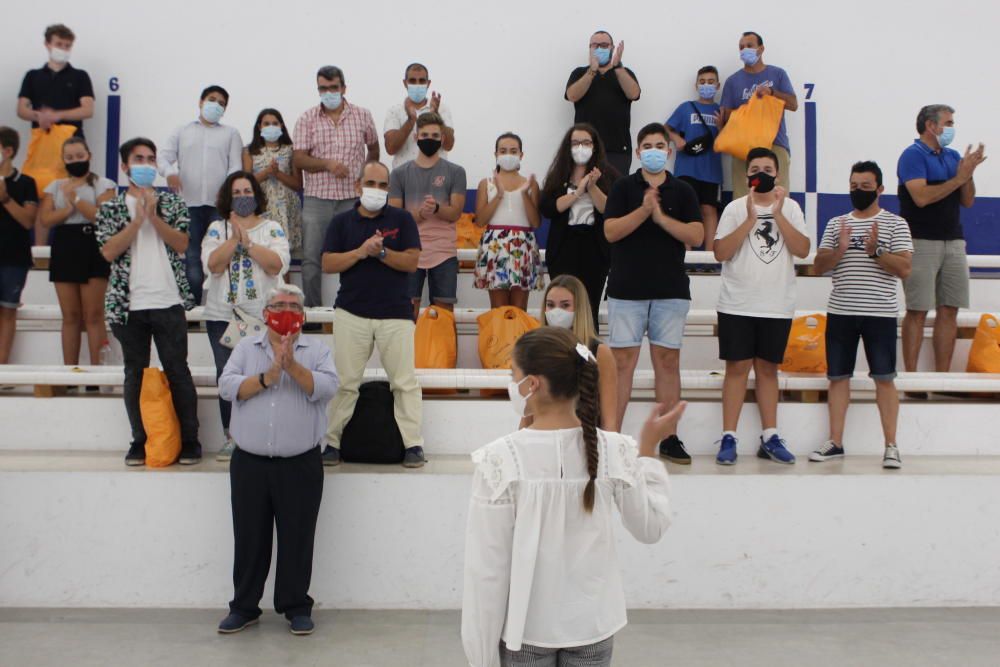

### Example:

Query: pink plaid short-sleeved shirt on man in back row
xmin=293 ymin=100 xmax=378 ymax=199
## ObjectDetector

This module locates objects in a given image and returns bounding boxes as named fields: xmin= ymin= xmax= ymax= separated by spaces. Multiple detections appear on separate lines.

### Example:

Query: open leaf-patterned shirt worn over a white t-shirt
xmin=94 ymin=192 xmax=194 ymax=324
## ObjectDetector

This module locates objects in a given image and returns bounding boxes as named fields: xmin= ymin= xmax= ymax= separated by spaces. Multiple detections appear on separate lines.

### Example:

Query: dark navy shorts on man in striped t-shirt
xmin=826 ymin=313 xmax=896 ymax=381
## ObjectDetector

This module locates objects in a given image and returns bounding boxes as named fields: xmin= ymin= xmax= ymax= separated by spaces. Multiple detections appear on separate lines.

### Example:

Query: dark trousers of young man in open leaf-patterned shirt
xmin=111 ymin=306 xmax=198 ymax=445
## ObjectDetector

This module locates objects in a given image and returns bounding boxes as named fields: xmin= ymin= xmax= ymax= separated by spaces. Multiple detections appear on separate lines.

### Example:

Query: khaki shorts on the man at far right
xmin=903 ymin=239 xmax=969 ymax=312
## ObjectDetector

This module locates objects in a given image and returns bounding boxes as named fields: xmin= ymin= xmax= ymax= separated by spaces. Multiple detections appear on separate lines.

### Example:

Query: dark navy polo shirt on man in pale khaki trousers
xmin=323 ymin=204 xmax=420 ymax=320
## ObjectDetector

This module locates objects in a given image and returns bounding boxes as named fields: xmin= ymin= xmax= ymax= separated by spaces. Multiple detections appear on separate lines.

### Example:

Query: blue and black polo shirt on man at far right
xmin=896 ymin=139 xmax=964 ymax=241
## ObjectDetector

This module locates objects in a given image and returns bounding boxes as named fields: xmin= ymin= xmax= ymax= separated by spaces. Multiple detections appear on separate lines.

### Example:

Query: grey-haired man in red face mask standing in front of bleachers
xmin=219 ymin=284 xmax=337 ymax=635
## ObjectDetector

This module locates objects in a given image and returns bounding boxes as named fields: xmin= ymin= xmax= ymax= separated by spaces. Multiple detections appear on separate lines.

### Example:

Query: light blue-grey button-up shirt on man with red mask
xmin=219 ymin=332 xmax=337 ymax=458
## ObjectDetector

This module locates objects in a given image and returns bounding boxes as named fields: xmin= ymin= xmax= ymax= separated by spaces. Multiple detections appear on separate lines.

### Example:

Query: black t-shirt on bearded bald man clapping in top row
xmin=566 ymin=67 xmax=639 ymax=153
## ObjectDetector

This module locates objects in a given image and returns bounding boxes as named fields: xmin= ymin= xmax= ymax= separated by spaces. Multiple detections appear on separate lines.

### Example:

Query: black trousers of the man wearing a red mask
xmin=229 ymin=447 xmax=323 ymax=620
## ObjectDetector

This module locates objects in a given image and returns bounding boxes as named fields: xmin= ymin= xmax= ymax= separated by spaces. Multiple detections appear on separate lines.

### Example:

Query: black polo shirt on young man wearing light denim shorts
xmin=604 ymin=169 xmax=701 ymax=301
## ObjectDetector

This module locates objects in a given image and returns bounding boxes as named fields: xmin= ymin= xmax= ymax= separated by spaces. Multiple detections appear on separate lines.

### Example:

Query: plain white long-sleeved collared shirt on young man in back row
xmin=156 ymin=120 xmax=243 ymax=206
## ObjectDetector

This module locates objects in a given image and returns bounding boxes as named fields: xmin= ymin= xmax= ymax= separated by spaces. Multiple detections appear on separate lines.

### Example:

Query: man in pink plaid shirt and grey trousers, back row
xmin=292 ymin=65 xmax=379 ymax=314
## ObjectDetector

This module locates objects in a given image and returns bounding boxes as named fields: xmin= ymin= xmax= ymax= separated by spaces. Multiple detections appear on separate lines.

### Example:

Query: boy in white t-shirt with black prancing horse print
xmin=714 ymin=148 xmax=810 ymax=465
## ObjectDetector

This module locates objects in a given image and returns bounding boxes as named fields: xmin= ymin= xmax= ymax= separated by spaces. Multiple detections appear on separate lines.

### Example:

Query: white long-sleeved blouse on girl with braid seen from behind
xmin=462 ymin=428 xmax=670 ymax=667
